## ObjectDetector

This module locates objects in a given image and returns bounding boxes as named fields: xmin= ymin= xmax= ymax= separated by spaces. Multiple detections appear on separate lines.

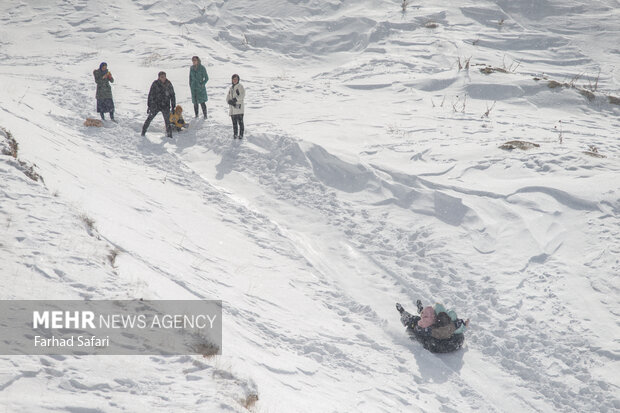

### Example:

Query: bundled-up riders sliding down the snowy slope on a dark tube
xmin=396 ymin=300 xmax=469 ymax=353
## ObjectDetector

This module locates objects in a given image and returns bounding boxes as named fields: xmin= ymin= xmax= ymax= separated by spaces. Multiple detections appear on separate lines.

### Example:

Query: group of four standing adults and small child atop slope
xmin=93 ymin=56 xmax=245 ymax=139
